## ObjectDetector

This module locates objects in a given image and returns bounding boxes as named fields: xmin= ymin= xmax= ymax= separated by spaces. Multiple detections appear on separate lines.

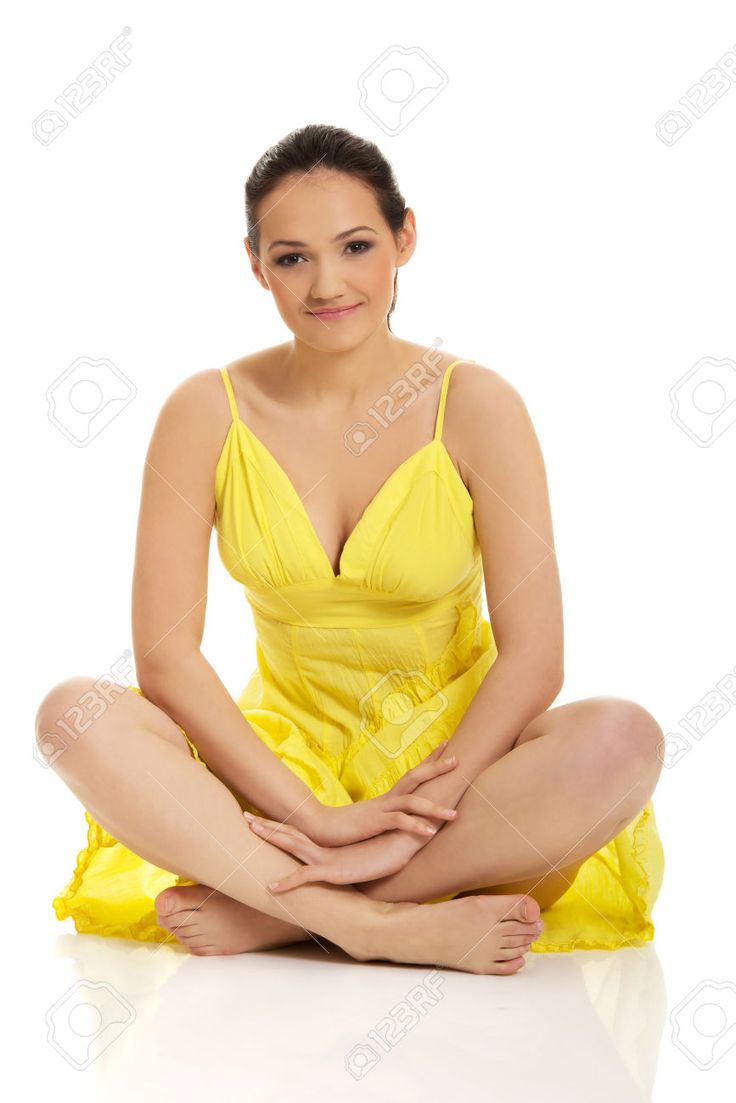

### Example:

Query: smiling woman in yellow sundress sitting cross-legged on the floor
xmin=36 ymin=126 xmax=663 ymax=974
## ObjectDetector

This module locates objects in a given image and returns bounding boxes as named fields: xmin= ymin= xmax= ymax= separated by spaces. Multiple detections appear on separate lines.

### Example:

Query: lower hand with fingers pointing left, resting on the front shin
xmin=244 ymin=816 xmax=429 ymax=895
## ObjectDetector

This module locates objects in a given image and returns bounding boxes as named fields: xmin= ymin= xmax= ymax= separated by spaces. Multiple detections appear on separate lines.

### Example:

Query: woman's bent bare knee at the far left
xmin=35 ymin=675 xmax=125 ymax=765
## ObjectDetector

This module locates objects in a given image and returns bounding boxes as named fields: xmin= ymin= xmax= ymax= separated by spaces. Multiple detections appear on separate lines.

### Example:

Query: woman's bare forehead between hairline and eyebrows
xmin=258 ymin=171 xmax=381 ymax=247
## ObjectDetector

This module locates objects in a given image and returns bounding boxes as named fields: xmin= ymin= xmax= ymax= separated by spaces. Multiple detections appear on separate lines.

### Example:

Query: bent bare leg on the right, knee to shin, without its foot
xmin=360 ymin=697 xmax=662 ymax=907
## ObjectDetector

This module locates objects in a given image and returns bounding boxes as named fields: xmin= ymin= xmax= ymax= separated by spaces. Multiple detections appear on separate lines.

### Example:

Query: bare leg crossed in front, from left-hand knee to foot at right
xmin=36 ymin=677 xmax=538 ymax=973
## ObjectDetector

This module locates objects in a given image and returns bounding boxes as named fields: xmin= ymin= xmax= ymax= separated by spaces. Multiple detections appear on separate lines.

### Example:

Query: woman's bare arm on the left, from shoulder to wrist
xmin=132 ymin=370 xmax=322 ymax=827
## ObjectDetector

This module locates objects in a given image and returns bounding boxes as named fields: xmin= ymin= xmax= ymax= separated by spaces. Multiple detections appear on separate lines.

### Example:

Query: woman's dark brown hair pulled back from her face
xmin=245 ymin=124 xmax=407 ymax=332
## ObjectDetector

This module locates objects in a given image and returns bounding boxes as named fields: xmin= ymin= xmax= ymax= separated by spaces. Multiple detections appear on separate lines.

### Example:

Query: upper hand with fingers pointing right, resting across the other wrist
xmin=286 ymin=739 xmax=458 ymax=846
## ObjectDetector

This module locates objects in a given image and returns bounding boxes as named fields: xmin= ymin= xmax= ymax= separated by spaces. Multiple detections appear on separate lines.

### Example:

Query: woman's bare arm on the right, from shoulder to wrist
xmin=390 ymin=364 xmax=564 ymax=820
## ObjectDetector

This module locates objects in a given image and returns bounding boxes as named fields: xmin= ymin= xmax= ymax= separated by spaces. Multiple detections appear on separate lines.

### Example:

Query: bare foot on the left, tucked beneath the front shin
xmin=154 ymin=885 xmax=310 ymax=956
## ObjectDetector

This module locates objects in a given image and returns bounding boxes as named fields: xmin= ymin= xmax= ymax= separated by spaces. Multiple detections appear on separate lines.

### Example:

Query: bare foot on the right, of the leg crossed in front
xmin=361 ymin=893 xmax=544 ymax=974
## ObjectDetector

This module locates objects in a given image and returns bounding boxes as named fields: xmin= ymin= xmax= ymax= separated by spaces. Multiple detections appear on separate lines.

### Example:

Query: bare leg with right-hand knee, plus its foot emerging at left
xmin=147 ymin=697 xmax=661 ymax=953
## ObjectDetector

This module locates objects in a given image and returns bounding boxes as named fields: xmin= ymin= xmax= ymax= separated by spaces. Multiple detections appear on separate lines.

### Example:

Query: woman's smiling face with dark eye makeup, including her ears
xmin=245 ymin=170 xmax=416 ymax=350
